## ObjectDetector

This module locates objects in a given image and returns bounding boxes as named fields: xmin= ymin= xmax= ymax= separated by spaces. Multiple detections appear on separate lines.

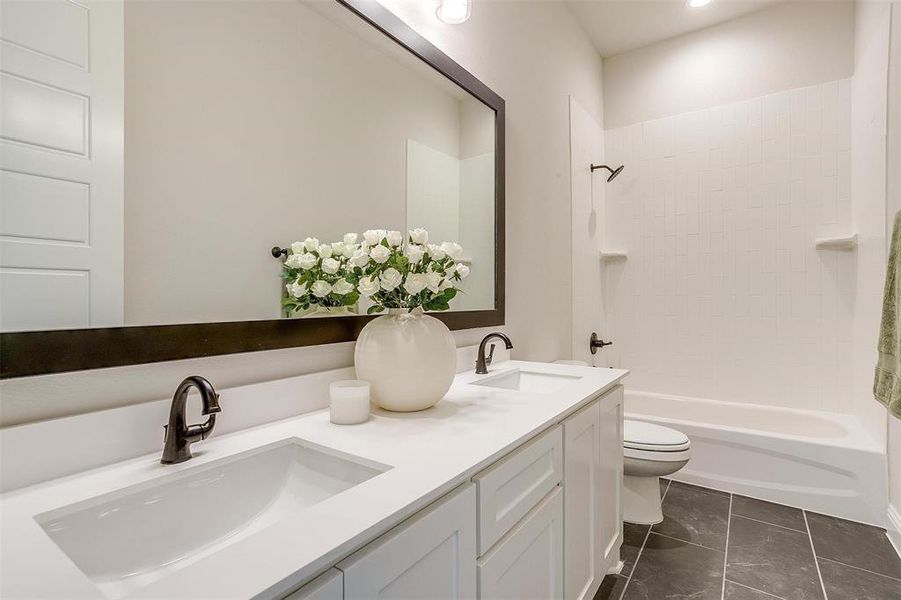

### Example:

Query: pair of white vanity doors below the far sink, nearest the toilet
xmin=563 ymin=386 xmax=623 ymax=600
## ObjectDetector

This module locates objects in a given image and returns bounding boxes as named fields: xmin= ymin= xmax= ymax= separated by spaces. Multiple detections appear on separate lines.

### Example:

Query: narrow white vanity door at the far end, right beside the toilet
xmin=598 ymin=385 xmax=623 ymax=577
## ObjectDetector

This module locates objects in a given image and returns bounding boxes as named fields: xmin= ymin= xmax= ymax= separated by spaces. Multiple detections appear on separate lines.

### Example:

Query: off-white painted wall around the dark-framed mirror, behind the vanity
xmin=0 ymin=0 xmax=602 ymax=427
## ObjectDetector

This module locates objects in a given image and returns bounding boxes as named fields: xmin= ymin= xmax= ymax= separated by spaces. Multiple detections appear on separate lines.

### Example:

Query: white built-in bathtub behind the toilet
xmin=625 ymin=388 xmax=886 ymax=527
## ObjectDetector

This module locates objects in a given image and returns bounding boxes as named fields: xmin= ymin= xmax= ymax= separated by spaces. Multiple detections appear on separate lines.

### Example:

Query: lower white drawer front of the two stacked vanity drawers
xmin=479 ymin=487 xmax=563 ymax=600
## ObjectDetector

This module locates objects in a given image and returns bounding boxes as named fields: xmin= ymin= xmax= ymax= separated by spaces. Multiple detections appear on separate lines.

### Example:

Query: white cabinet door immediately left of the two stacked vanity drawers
xmin=338 ymin=484 xmax=476 ymax=600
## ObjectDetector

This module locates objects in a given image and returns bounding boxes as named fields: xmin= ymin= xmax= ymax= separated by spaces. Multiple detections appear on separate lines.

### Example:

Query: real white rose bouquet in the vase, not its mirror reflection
xmin=350 ymin=229 xmax=469 ymax=314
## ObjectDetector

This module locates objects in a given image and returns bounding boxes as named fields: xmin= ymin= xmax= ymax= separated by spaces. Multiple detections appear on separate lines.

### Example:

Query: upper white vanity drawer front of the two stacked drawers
xmin=473 ymin=426 xmax=563 ymax=555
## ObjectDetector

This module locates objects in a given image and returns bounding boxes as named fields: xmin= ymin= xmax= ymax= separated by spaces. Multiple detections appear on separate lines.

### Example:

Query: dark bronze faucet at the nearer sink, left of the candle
xmin=160 ymin=375 xmax=222 ymax=465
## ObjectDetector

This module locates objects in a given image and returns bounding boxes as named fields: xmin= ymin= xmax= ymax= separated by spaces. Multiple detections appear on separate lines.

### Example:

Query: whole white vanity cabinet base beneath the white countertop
xmin=278 ymin=386 xmax=623 ymax=600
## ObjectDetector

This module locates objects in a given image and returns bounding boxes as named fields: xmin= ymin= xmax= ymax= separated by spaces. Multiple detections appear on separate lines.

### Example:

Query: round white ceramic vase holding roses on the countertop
xmin=354 ymin=308 xmax=457 ymax=412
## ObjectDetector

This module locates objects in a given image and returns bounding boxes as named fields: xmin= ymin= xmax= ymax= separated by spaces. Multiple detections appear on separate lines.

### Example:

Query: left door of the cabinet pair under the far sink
xmin=563 ymin=400 xmax=604 ymax=600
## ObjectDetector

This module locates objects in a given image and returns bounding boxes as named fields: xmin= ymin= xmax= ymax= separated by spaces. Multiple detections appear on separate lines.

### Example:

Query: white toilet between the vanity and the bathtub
xmin=622 ymin=419 xmax=691 ymax=525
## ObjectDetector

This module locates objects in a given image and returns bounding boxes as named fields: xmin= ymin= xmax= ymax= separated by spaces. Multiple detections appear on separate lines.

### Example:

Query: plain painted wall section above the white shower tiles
xmin=604 ymin=1 xmax=854 ymax=129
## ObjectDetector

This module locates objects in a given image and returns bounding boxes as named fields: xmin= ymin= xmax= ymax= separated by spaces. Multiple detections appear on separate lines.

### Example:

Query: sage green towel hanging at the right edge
xmin=873 ymin=211 xmax=901 ymax=419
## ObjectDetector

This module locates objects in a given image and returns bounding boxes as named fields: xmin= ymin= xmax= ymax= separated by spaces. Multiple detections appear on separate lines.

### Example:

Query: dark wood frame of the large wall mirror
xmin=0 ymin=0 xmax=505 ymax=379
